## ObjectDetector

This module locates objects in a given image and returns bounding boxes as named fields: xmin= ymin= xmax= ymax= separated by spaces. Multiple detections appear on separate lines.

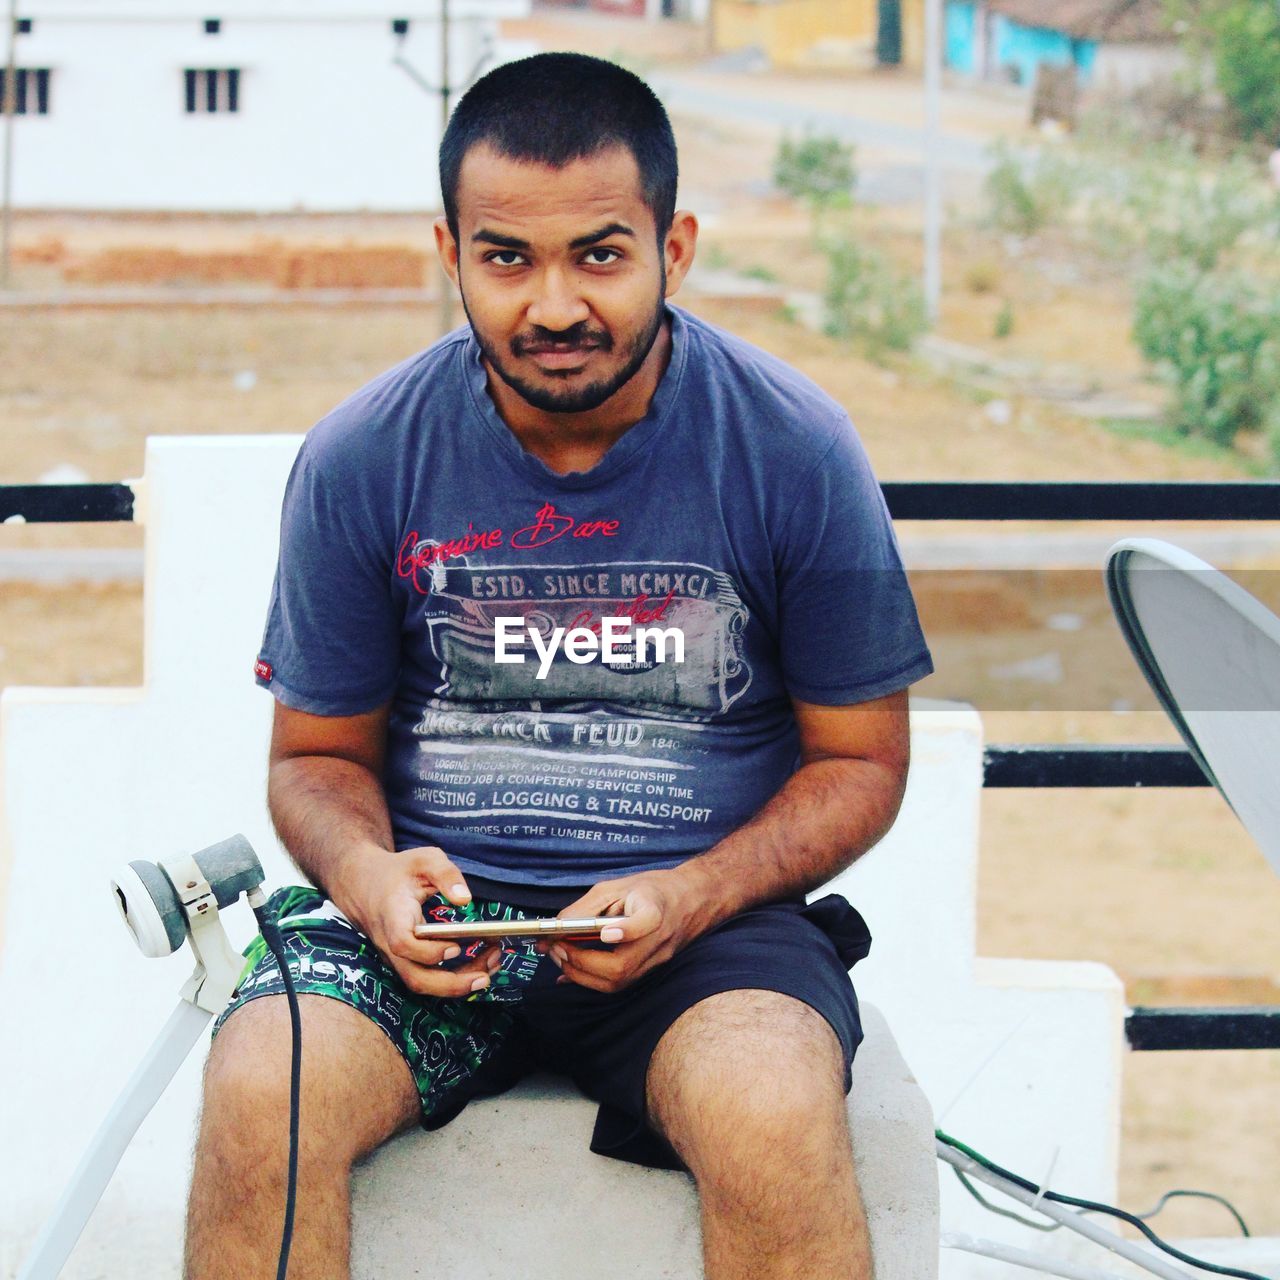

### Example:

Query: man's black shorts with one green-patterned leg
xmin=214 ymin=887 xmax=870 ymax=1169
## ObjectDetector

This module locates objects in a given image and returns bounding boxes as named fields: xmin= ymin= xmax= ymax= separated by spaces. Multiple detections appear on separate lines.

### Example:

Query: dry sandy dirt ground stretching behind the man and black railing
xmin=0 ymin=27 xmax=1280 ymax=1235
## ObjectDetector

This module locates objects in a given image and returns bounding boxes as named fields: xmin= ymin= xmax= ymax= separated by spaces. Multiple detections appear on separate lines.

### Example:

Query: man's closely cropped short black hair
xmin=440 ymin=54 xmax=678 ymax=239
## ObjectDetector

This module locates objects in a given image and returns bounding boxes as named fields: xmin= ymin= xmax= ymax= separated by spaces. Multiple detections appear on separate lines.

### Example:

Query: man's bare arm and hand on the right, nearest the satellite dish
xmin=553 ymin=691 xmax=910 ymax=991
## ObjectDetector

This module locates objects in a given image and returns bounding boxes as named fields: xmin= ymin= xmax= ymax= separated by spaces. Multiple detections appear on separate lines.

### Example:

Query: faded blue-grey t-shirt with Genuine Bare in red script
xmin=256 ymin=307 xmax=932 ymax=886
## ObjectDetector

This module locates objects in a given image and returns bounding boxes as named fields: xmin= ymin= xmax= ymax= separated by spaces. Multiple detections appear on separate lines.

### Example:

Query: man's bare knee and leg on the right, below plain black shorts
xmin=648 ymin=991 xmax=872 ymax=1280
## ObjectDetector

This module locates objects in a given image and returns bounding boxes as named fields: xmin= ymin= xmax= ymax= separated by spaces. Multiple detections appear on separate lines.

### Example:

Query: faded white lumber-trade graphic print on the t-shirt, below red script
xmin=399 ymin=543 xmax=751 ymax=845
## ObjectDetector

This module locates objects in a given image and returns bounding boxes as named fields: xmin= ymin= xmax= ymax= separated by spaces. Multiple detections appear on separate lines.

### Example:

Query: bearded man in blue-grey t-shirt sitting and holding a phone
xmin=187 ymin=54 xmax=929 ymax=1280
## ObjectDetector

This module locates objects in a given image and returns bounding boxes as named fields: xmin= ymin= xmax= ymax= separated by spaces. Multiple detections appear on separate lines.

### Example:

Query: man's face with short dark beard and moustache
xmin=436 ymin=145 xmax=684 ymax=413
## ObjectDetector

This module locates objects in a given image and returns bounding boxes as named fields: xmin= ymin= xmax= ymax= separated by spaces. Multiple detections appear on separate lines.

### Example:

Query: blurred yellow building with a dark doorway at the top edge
xmin=710 ymin=0 xmax=924 ymax=70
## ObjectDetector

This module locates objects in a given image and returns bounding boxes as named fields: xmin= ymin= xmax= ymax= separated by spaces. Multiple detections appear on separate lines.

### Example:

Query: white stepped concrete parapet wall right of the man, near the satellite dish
xmin=833 ymin=703 xmax=1124 ymax=1280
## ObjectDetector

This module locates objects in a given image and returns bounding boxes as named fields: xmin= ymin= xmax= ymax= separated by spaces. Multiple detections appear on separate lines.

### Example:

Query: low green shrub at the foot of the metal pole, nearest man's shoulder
xmin=822 ymin=238 xmax=928 ymax=358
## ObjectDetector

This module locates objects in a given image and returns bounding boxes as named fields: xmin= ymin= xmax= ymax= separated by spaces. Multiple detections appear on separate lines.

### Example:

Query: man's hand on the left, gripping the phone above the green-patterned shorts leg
xmin=330 ymin=846 xmax=502 ymax=997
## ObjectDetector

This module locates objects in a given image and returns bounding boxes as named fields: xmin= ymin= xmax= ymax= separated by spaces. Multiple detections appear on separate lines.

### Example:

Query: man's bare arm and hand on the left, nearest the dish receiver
xmin=268 ymin=703 xmax=500 ymax=996
